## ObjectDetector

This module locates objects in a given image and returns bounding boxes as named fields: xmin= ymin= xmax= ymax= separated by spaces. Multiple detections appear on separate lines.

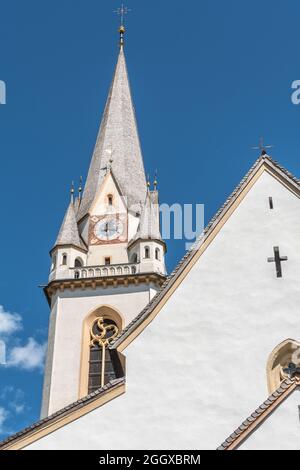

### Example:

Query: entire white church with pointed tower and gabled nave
xmin=0 ymin=26 xmax=300 ymax=450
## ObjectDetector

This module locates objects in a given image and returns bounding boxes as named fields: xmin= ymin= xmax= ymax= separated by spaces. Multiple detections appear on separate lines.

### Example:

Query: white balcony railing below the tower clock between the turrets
xmin=69 ymin=263 xmax=140 ymax=279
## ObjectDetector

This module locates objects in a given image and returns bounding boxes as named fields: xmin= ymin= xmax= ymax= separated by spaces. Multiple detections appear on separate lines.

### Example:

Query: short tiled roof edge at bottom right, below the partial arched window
xmin=217 ymin=379 xmax=295 ymax=450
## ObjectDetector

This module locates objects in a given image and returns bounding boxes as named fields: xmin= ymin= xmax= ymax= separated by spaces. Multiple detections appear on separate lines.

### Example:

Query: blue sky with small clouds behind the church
xmin=0 ymin=0 xmax=300 ymax=438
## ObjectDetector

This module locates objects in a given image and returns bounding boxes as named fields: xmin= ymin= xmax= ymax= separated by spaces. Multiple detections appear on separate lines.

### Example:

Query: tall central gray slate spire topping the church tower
xmin=77 ymin=47 xmax=146 ymax=220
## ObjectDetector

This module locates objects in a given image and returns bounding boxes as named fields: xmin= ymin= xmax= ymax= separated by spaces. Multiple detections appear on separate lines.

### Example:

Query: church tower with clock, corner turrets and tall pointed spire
xmin=42 ymin=26 xmax=166 ymax=417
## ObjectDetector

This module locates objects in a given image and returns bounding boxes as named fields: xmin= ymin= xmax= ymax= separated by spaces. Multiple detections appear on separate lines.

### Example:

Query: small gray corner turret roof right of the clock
xmin=134 ymin=191 xmax=162 ymax=240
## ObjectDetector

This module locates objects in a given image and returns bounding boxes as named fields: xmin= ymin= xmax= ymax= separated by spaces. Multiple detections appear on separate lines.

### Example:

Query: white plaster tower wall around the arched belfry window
xmin=42 ymin=284 xmax=156 ymax=416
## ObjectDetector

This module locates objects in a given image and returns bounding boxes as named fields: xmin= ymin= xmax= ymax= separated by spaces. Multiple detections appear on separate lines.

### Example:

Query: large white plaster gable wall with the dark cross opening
xmin=30 ymin=172 xmax=300 ymax=449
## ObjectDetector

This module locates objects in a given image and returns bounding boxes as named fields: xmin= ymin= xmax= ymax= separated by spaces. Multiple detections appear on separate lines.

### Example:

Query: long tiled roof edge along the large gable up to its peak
xmin=110 ymin=155 xmax=300 ymax=348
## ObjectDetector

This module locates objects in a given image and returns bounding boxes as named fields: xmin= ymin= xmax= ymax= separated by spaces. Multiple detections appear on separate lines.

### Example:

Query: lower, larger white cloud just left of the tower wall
xmin=7 ymin=338 xmax=46 ymax=370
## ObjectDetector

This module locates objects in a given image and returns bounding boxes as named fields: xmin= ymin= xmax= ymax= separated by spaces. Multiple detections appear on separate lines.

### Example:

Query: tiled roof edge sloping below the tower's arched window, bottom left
xmin=0 ymin=377 xmax=125 ymax=450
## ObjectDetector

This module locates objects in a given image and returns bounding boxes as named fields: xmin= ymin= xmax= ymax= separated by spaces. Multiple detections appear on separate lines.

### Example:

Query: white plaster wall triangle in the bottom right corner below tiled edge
xmin=239 ymin=389 xmax=300 ymax=450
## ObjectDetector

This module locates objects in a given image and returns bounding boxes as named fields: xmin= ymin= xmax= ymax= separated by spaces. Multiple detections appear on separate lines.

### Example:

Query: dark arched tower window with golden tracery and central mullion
xmin=88 ymin=317 xmax=123 ymax=393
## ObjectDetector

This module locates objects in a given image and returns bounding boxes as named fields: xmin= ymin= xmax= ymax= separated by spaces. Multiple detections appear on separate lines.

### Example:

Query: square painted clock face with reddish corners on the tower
xmin=89 ymin=214 xmax=127 ymax=245
